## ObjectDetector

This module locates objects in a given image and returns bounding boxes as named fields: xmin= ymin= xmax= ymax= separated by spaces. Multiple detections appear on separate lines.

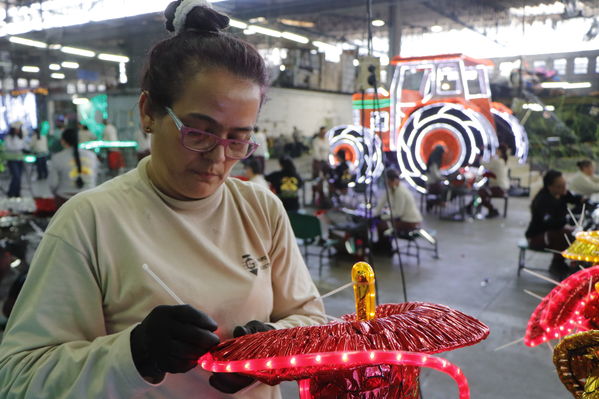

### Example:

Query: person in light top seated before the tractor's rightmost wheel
xmin=478 ymin=144 xmax=510 ymax=219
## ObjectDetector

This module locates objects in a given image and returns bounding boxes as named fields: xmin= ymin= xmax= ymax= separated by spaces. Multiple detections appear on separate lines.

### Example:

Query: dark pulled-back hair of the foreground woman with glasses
xmin=141 ymin=0 xmax=268 ymax=115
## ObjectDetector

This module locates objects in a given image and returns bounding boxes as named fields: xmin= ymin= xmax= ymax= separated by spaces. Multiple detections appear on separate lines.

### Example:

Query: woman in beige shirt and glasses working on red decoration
xmin=0 ymin=0 xmax=325 ymax=399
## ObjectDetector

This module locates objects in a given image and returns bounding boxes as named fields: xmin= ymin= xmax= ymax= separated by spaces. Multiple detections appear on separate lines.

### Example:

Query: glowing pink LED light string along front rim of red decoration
xmin=198 ymin=350 xmax=470 ymax=399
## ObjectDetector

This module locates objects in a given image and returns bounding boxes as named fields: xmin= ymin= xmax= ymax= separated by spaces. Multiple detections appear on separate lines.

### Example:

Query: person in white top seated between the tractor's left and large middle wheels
xmin=373 ymin=169 xmax=422 ymax=237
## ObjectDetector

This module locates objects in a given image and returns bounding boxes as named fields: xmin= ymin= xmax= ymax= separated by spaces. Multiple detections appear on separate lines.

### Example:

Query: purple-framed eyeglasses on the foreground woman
xmin=165 ymin=107 xmax=259 ymax=159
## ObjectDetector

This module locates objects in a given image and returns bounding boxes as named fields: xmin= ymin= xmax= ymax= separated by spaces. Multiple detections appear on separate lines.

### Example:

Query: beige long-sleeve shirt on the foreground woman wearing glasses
xmin=0 ymin=158 xmax=325 ymax=399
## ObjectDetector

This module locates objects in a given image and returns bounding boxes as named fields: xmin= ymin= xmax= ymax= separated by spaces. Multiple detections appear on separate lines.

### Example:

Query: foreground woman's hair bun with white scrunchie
xmin=164 ymin=0 xmax=229 ymax=34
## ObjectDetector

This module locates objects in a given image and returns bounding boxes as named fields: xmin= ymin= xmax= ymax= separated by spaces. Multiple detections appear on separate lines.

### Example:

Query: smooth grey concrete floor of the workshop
xmin=1 ymin=159 xmax=569 ymax=399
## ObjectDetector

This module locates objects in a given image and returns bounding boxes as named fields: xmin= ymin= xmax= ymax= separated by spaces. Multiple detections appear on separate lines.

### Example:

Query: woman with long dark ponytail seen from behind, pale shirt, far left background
xmin=50 ymin=129 xmax=98 ymax=208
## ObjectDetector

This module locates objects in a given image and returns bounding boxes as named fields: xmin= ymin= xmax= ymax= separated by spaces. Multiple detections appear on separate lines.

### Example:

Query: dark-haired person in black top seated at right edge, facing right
xmin=525 ymin=170 xmax=582 ymax=279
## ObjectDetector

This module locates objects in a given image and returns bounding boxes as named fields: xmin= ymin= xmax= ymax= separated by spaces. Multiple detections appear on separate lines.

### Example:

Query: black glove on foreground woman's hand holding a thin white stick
xmin=130 ymin=305 xmax=220 ymax=382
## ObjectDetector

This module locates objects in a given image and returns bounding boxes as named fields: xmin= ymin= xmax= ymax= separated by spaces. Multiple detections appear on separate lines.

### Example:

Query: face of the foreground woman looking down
xmin=140 ymin=68 xmax=261 ymax=200
